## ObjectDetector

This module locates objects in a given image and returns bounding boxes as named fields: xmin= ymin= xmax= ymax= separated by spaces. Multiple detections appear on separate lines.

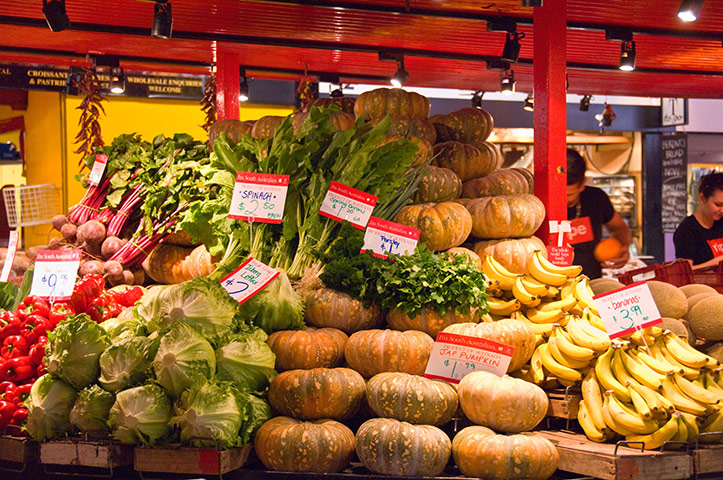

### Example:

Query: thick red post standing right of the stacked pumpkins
xmin=533 ymin=0 xmax=567 ymax=244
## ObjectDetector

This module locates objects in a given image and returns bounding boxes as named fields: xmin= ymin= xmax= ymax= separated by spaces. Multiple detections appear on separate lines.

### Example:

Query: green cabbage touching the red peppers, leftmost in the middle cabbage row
xmin=45 ymin=313 xmax=110 ymax=390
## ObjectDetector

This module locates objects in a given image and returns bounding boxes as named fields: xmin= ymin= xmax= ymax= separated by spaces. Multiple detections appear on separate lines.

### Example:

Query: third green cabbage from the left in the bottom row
xmin=108 ymin=384 xmax=172 ymax=445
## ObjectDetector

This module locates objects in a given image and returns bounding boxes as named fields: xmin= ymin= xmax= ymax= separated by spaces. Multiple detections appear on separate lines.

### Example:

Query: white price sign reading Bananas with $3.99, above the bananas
xmin=593 ymin=282 xmax=663 ymax=339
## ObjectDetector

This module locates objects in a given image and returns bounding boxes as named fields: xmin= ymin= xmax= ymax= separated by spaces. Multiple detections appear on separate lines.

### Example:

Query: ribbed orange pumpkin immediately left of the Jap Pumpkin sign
xmin=344 ymin=329 xmax=434 ymax=378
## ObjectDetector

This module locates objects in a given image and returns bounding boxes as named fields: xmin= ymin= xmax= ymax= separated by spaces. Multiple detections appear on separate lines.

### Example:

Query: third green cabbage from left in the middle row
xmin=153 ymin=322 xmax=216 ymax=398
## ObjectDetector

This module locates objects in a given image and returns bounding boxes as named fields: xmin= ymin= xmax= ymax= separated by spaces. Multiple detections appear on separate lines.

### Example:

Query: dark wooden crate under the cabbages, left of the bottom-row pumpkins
xmin=133 ymin=444 xmax=251 ymax=475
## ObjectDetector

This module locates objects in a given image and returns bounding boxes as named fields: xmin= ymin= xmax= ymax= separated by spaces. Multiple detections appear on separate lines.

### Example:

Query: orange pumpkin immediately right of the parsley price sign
xmin=394 ymin=202 xmax=472 ymax=251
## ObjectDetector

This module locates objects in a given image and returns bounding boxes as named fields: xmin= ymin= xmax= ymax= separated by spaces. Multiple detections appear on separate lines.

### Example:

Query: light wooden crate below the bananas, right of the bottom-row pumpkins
xmin=539 ymin=430 xmax=693 ymax=480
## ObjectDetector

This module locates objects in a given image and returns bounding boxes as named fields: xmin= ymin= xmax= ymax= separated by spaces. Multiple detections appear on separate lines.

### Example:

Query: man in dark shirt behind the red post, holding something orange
xmin=567 ymin=148 xmax=633 ymax=279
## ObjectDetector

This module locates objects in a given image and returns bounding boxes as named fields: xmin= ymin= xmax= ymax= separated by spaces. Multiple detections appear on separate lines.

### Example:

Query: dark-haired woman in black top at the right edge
xmin=673 ymin=172 xmax=723 ymax=269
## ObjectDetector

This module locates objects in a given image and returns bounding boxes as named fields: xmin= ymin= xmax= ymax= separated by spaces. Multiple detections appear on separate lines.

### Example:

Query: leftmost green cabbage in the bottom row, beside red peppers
xmin=25 ymin=374 xmax=76 ymax=442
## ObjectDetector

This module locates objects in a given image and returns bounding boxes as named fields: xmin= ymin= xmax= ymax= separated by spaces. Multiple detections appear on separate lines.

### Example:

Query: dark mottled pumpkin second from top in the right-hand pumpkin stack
xmin=434 ymin=141 xmax=500 ymax=182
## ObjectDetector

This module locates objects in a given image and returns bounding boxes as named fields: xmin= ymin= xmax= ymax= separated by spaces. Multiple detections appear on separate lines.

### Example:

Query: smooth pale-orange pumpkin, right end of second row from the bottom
xmin=457 ymin=370 xmax=549 ymax=433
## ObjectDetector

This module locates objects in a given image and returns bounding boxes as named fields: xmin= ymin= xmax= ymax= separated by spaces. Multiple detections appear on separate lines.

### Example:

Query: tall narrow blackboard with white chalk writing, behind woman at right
xmin=660 ymin=133 xmax=688 ymax=232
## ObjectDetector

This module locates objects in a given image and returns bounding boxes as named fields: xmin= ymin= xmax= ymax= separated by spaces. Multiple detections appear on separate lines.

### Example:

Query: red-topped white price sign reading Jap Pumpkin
xmin=424 ymin=332 xmax=515 ymax=383
